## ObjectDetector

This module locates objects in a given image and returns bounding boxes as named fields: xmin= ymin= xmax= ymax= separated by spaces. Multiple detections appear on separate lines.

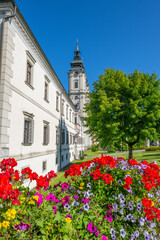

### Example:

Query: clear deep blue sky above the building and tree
xmin=15 ymin=0 xmax=160 ymax=91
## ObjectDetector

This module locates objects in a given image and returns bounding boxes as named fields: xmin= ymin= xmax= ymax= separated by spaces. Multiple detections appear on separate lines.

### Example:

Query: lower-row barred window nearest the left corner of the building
xmin=23 ymin=112 xmax=34 ymax=145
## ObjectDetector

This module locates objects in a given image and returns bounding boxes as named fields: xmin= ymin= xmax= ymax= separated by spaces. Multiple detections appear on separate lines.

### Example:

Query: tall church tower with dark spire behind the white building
xmin=68 ymin=40 xmax=90 ymax=117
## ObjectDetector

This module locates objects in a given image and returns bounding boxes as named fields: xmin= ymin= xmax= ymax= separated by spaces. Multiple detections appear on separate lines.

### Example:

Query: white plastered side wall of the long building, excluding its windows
xmin=0 ymin=1 xmax=90 ymax=180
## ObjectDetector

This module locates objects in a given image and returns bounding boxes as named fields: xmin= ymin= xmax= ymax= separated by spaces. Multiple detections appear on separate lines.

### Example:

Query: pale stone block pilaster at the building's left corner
xmin=0 ymin=21 xmax=15 ymax=158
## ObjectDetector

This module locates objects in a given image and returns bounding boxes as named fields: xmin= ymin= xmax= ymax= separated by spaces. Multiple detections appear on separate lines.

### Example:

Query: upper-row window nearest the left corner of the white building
xmin=25 ymin=51 xmax=36 ymax=89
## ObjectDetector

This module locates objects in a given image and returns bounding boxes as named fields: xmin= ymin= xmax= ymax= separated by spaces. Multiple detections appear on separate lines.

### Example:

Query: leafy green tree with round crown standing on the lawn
xmin=84 ymin=69 xmax=160 ymax=158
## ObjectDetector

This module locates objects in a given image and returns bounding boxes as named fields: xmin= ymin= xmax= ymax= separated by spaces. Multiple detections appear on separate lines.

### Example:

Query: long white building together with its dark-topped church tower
xmin=0 ymin=0 xmax=91 ymax=174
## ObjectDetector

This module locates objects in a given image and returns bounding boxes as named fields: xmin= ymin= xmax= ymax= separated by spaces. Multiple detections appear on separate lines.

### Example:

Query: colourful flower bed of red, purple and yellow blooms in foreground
xmin=0 ymin=155 xmax=160 ymax=240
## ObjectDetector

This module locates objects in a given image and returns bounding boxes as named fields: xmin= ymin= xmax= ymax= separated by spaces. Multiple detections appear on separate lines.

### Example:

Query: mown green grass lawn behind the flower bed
xmin=51 ymin=150 xmax=160 ymax=184
